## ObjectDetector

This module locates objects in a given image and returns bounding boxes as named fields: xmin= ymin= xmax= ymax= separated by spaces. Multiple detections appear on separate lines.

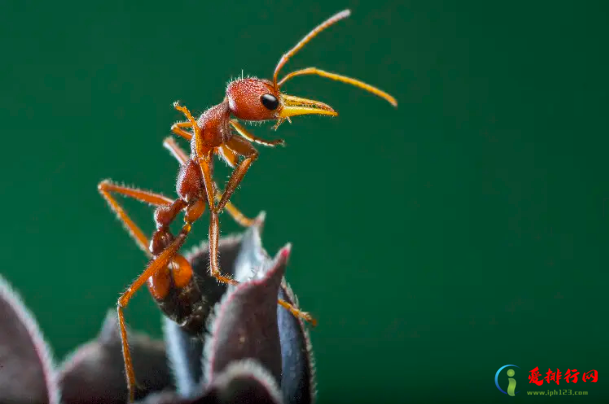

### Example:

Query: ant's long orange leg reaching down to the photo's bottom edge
xmin=116 ymin=223 xmax=191 ymax=402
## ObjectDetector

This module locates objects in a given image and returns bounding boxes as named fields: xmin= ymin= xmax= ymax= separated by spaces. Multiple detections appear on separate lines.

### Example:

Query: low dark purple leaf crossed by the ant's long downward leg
xmin=59 ymin=311 xmax=172 ymax=404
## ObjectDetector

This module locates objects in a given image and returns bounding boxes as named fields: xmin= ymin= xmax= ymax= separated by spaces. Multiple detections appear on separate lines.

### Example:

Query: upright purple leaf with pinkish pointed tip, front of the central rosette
xmin=205 ymin=245 xmax=290 ymax=382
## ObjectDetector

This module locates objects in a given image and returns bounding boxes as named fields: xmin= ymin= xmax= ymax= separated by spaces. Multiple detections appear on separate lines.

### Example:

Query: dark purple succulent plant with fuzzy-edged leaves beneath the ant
xmin=0 ymin=217 xmax=315 ymax=404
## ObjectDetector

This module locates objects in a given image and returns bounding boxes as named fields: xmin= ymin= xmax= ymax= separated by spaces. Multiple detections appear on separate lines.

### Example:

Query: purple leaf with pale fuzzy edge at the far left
xmin=0 ymin=276 xmax=59 ymax=404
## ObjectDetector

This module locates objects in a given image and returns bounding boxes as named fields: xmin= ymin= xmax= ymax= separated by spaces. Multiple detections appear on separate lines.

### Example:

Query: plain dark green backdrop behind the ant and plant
xmin=0 ymin=0 xmax=609 ymax=403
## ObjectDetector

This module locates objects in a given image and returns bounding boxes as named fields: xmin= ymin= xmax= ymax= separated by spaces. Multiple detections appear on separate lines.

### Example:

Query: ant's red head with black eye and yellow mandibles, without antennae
xmin=226 ymin=78 xmax=337 ymax=121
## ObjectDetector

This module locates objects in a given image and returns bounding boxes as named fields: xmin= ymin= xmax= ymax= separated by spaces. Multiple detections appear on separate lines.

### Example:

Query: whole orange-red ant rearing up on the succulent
xmin=98 ymin=10 xmax=397 ymax=401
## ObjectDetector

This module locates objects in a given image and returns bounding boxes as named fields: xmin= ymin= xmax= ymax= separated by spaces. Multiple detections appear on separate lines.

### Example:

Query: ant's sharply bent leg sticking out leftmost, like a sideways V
xmin=97 ymin=180 xmax=174 ymax=257
